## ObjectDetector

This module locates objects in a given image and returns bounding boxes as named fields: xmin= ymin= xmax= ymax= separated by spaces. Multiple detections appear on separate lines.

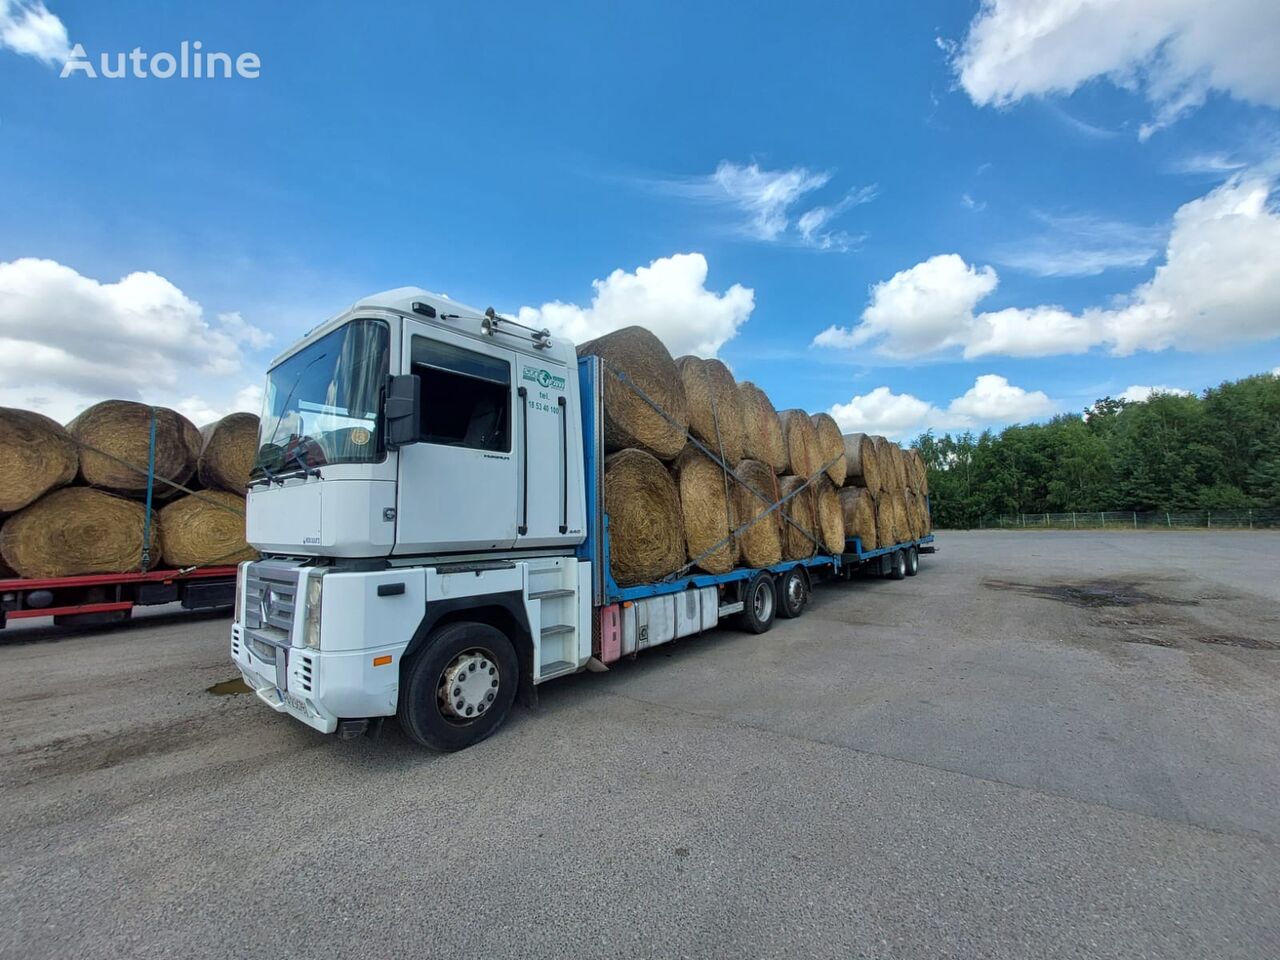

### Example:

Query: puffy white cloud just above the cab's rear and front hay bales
xmin=518 ymin=253 xmax=755 ymax=357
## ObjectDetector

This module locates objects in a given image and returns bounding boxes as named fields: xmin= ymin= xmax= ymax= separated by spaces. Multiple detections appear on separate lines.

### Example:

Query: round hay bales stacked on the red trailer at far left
xmin=0 ymin=401 xmax=257 ymax=579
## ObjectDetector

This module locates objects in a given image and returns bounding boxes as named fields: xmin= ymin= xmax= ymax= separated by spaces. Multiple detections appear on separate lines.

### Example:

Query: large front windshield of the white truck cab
xmin=253 ymin=320 xmax=390 ymax=477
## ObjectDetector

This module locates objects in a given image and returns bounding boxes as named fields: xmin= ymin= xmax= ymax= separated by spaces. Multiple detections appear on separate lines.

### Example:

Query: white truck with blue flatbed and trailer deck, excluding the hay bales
xmin=232 ymin=288 xmax=933 ymax=750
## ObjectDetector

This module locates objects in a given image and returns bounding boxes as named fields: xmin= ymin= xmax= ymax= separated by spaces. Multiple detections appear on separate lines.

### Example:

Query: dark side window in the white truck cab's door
xmin=411 ymin=337 xmax=511 ymax=453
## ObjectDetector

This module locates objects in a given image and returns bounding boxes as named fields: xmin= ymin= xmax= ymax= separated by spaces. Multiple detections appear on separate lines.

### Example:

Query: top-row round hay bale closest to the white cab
xmin=577 ymin=326 xmax=689 ymax=460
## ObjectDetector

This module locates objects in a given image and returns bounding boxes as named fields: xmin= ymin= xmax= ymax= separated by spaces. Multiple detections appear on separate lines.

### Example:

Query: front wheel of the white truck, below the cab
xmin=396 ymin=621 xmax=520 ymax=753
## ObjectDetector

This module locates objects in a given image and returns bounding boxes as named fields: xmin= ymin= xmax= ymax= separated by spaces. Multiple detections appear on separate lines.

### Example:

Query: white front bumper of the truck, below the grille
xmin=232 ymin=623 xmax=404 ymax=733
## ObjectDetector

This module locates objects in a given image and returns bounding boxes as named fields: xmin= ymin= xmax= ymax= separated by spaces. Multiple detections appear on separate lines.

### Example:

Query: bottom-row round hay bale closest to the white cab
xmin=604 ymin=451 xmax=685 ymax=586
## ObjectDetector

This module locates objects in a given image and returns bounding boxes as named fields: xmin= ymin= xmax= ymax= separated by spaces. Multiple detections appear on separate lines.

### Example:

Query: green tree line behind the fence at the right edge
xmin=913 ymin=374 xmax=1280 ymax=527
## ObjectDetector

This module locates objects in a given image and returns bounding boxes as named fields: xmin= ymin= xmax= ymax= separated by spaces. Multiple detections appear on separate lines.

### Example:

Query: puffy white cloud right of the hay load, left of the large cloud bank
xmin=813 ymin=253 xmax=997 ymax=357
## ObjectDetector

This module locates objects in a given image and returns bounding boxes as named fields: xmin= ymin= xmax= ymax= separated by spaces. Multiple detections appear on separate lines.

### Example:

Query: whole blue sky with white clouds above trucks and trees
xmin=0 ymin=0 xmax=1280 ymax=436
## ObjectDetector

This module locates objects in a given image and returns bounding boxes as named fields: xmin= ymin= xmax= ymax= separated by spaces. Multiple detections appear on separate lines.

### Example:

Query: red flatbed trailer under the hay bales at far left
xmin=0 ymin=566 xmax=236 ymax=630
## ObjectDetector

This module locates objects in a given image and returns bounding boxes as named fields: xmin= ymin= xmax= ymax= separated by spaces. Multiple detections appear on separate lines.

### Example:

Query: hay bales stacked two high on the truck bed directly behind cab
xmin=593 ymin=328 xmax=846 ymax=586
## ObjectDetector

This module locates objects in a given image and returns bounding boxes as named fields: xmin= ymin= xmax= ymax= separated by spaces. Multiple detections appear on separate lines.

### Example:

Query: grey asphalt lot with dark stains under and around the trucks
xmin=0 ymin=532 xmax=1280 ymax=960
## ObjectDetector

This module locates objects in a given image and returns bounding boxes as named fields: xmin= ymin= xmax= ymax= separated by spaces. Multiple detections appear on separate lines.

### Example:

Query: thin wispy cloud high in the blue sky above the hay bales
xmin=662 ymin=160 xmax=878 ymax=251
